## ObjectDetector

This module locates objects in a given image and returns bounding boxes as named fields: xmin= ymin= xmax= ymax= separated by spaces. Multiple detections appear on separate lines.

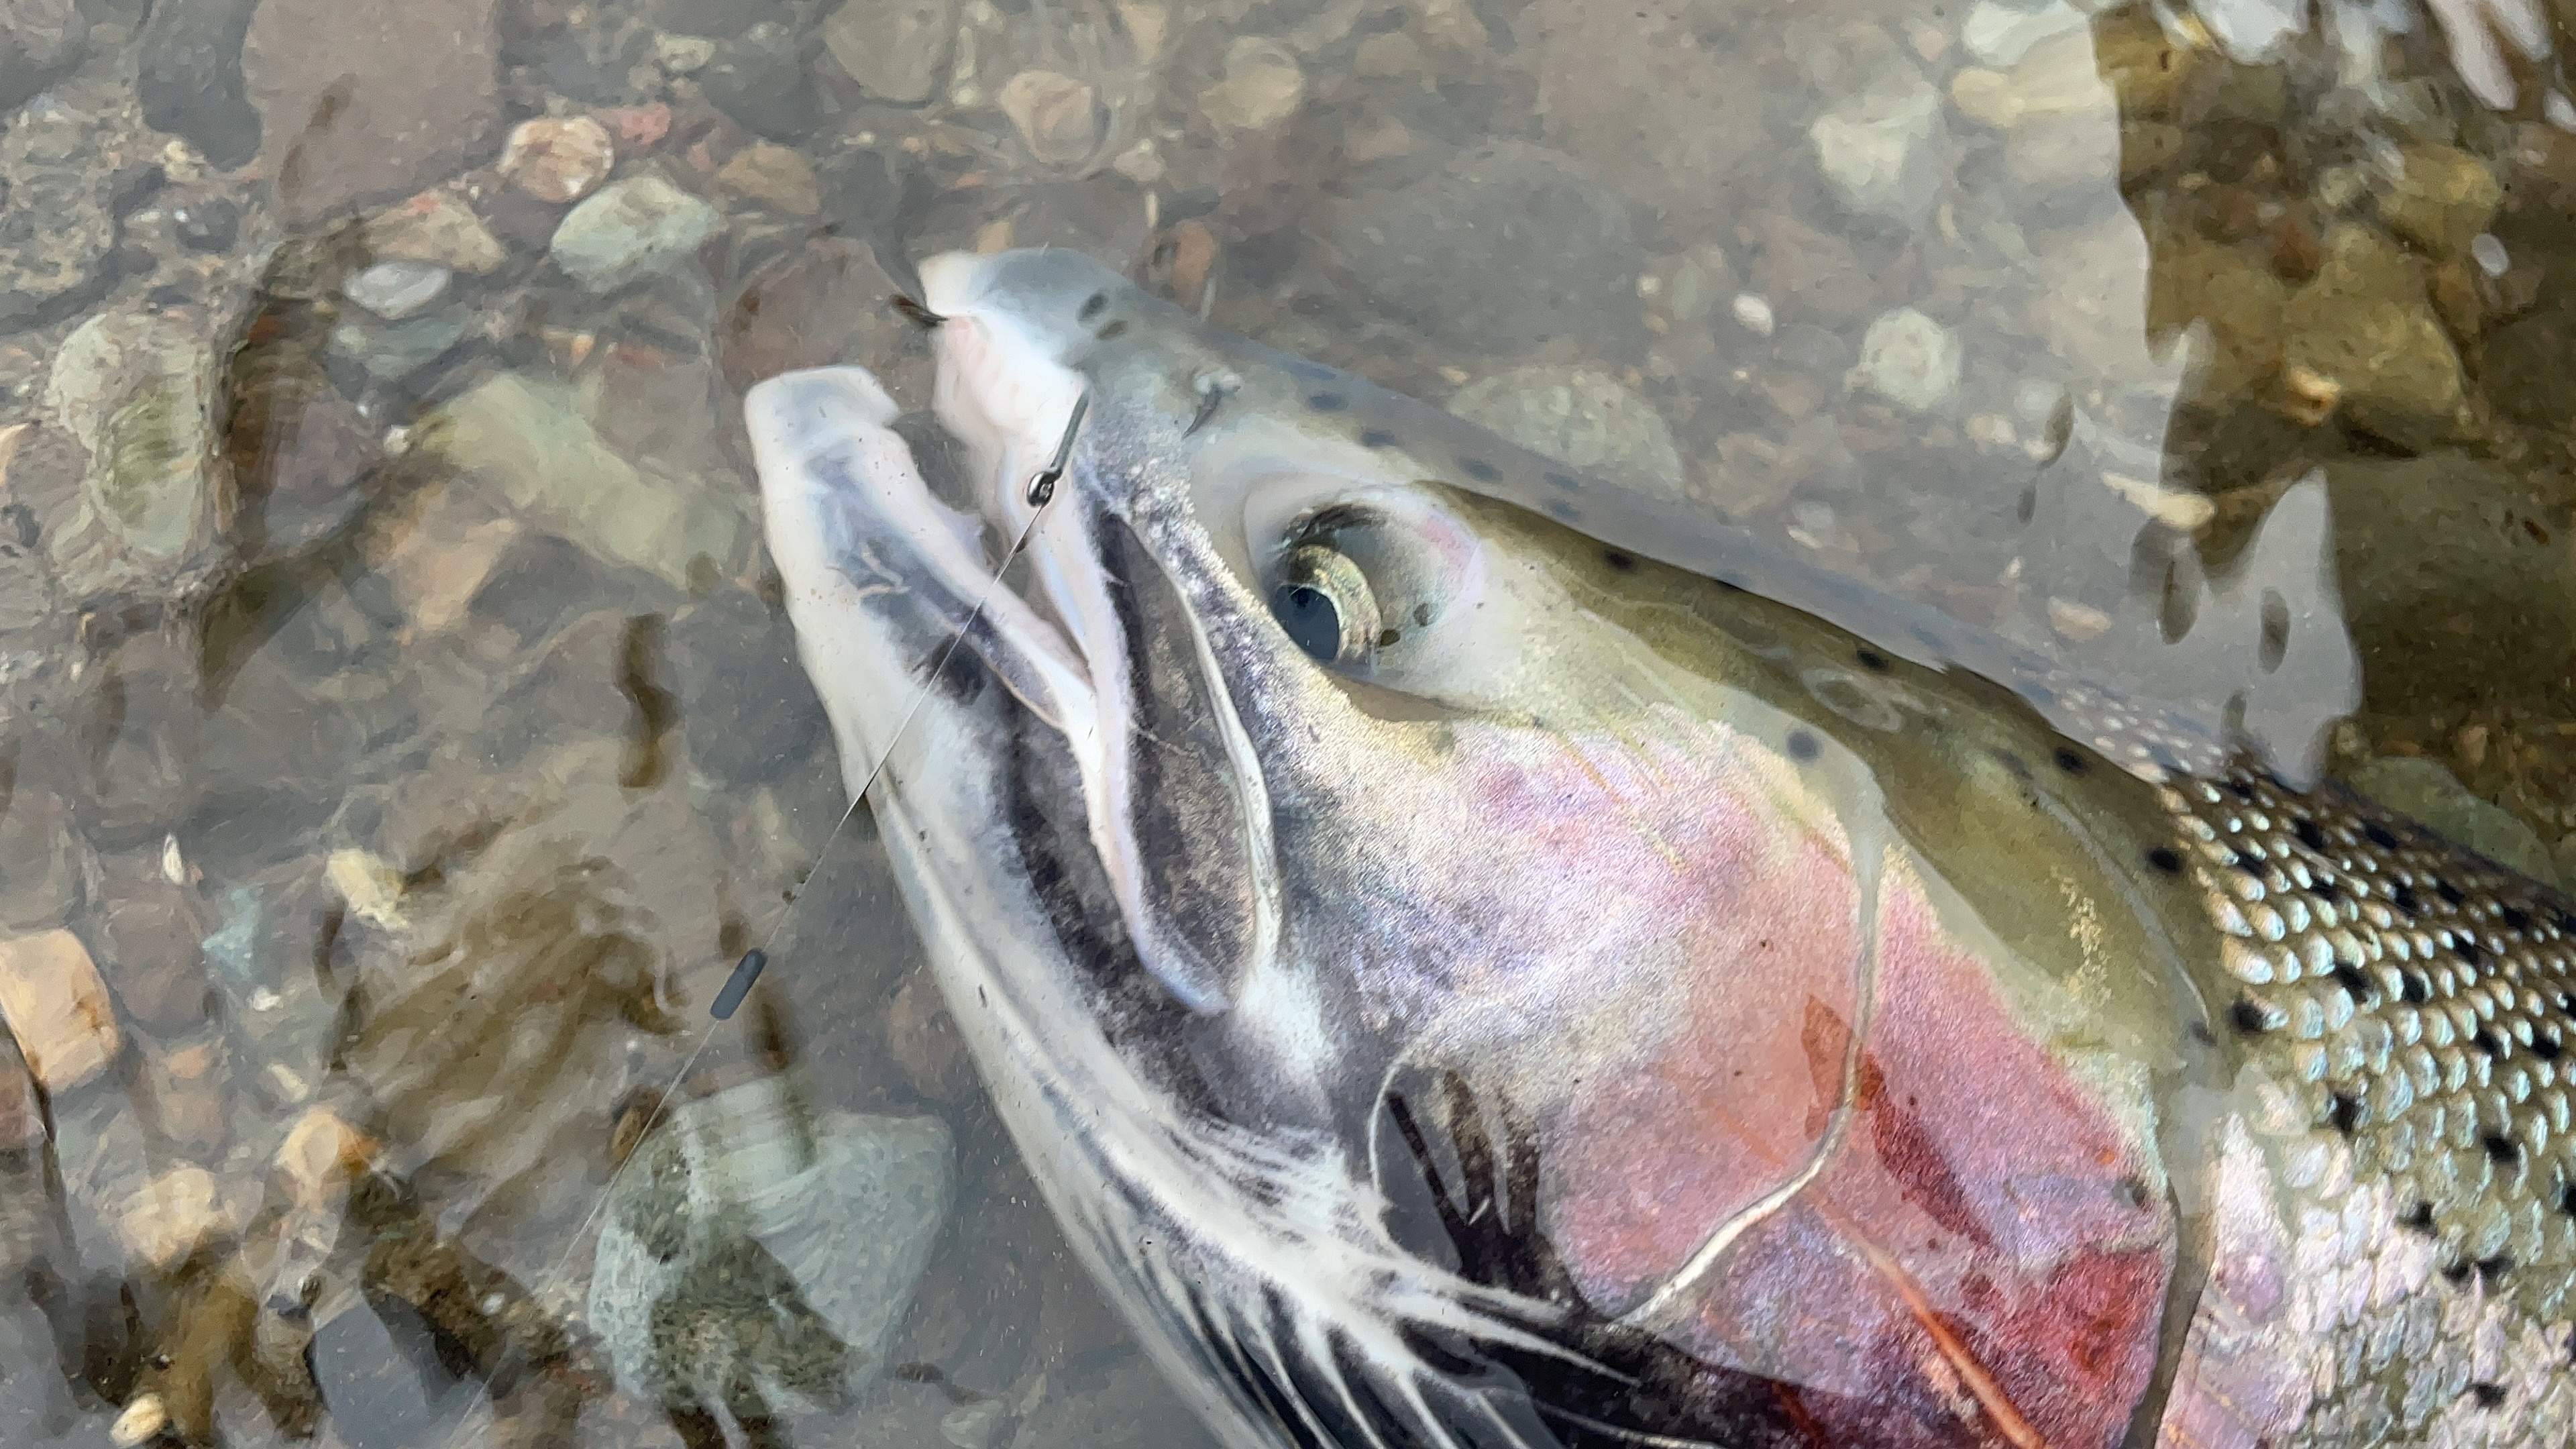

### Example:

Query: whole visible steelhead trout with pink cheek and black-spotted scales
xmin=747 ymin=250 xmax=2576 ymax=1449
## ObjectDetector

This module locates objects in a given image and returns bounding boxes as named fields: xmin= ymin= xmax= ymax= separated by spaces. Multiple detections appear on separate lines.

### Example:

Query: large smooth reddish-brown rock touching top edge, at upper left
xmin=242 ymin=0 xmax=500 ymax=224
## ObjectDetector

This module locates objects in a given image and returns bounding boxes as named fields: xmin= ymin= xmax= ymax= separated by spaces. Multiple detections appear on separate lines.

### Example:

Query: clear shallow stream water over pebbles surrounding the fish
xmin=0 ymin=0 xmax=2576 ymax=1449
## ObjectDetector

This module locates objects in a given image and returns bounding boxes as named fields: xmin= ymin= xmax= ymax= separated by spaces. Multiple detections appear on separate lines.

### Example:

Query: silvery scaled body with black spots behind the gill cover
xmin=2159 ymin=768 xmax=2576 ymax=1446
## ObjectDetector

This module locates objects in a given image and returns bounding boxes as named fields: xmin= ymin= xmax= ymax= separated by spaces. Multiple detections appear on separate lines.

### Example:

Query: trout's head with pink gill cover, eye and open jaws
xmin=747 ymin=253 xmax=2187 ymax=1446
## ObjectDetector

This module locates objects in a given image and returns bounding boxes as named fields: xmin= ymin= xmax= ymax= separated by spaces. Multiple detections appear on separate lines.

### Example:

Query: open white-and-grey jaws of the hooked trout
xmin=745 ymin=253 xmax=1280 ymax=1013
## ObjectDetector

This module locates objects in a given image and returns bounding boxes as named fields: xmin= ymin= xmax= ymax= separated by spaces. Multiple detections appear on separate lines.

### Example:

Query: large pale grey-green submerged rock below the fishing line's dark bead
xmin=590 ymin=1078 xmax=956 ymax=1418
